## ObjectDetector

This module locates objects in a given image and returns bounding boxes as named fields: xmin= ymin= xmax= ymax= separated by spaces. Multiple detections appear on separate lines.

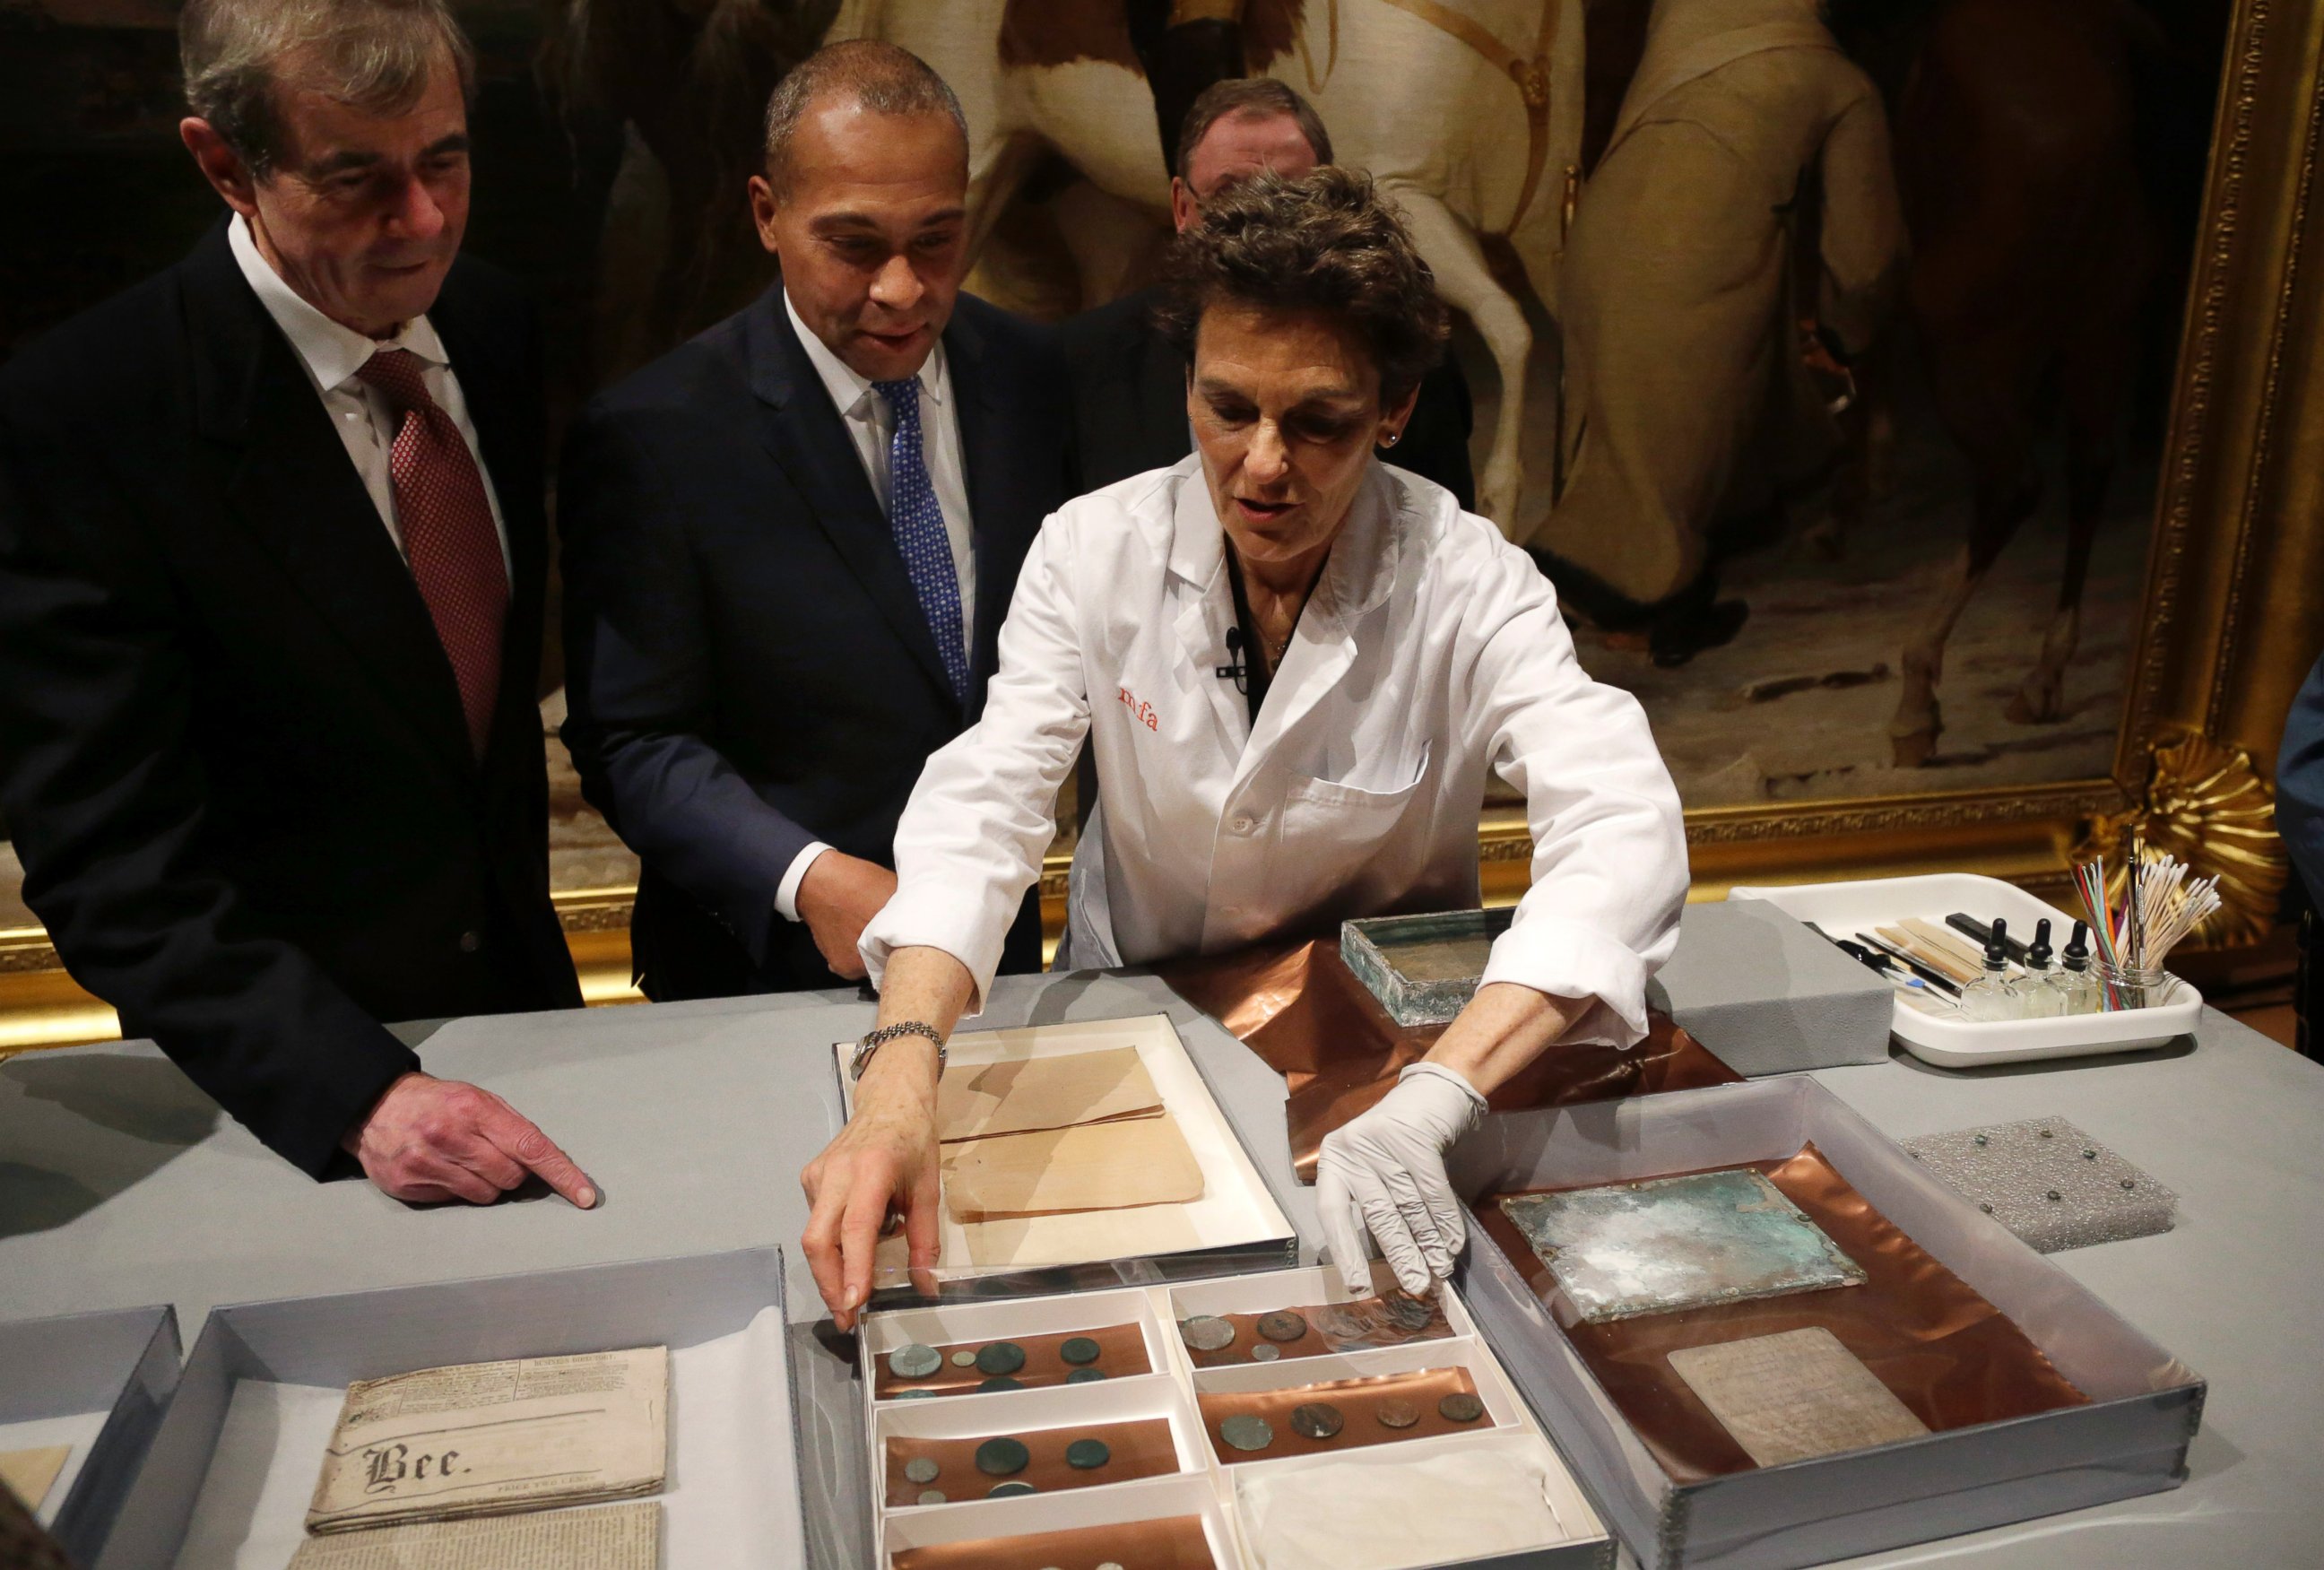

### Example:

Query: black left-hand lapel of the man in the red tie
xmin=186 ymin=225 xmax=474 ymax=776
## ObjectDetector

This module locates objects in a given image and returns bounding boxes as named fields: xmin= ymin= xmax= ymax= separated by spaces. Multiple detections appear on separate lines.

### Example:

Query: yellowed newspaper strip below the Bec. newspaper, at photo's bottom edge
xmin=290 ymin=1500 xmax=663 ymax=1570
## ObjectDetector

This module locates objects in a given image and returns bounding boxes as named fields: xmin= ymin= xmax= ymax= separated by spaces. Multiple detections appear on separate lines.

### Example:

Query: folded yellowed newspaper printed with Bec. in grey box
xmin=307 ymin=1347 xmax=669 ymax=1533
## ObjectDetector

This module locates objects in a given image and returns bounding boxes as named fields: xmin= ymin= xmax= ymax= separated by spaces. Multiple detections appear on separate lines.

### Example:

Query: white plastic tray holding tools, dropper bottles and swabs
xmin=1727 ymin=873 xmax=2203 ymax=1069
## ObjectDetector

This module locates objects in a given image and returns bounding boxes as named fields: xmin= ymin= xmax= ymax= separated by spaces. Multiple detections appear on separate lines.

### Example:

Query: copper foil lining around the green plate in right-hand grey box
xmin=1476 ymin=1145 xmax=2087 ymax=1482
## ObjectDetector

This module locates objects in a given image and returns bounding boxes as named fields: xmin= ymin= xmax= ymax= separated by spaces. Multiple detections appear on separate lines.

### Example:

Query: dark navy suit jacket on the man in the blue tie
xmin=558 ymin=286 xmax=1071 ymax=999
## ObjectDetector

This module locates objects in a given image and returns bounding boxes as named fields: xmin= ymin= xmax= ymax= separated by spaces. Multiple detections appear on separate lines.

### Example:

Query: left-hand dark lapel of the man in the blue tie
xmin=746 ymin=283 xmax=974 ymax=699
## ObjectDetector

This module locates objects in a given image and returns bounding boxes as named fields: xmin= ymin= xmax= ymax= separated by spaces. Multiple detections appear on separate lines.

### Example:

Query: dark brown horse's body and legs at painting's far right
xmin=1889 ymin=0 xmax=2143 ymax=768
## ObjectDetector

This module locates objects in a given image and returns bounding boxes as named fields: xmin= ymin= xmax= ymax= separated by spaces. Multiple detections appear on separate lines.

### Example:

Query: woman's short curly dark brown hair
xmin=1155 ymin=165 xmax=1448 ymax=406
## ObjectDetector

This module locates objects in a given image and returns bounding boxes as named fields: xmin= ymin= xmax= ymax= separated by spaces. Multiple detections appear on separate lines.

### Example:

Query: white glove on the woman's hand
xmin=1315 ymin=1063 xmax=1485 ymax=1296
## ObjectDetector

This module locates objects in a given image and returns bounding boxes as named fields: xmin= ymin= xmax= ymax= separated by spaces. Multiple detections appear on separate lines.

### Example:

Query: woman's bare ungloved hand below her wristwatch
xmin=800 ymin=1040 xmax=943 ymax=1331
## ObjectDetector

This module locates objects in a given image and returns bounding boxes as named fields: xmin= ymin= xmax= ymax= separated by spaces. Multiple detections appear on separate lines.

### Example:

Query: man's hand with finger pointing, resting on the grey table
xmin=342 ymin=1071 xmax=597 ymax=1210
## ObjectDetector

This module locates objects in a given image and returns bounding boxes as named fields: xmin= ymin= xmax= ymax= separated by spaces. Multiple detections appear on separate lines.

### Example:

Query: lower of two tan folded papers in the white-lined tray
xmin=943 ymin=1113 xmax=1201 ymax=1221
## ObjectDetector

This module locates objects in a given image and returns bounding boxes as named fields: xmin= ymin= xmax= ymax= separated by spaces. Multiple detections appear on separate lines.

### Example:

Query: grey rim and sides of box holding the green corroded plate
xmin=1452 ymin=1078 xmax=2203 ymax=1570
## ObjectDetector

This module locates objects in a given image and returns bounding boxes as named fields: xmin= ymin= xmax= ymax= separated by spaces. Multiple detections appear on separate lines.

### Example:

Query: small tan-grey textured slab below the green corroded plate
xmin=1671 ymin=1326 xmax=1929 ymax=1465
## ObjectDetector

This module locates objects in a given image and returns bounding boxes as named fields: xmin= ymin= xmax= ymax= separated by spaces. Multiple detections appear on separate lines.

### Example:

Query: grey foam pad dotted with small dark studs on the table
xmin=1903 ymin=1117 xmax=2178 ymax=1254
